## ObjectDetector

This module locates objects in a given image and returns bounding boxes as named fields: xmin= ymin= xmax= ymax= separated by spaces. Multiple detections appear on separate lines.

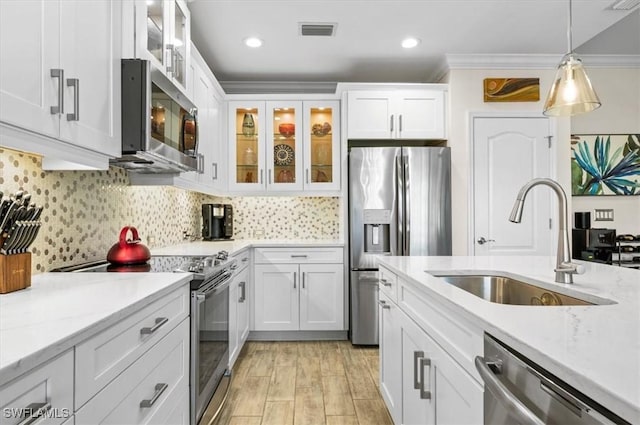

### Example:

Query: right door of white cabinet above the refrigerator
xmin=395 ymin=90 xmax=445 ymax=139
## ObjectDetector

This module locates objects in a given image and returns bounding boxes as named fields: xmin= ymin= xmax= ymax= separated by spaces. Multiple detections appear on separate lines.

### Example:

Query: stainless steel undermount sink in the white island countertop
xmin=430 ymin=273 xmax=614 ymax=306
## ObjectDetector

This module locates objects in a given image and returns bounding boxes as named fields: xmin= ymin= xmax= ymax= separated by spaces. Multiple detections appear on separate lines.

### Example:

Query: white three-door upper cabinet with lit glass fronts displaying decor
xmin=228 ymin=100 xmax=340 ymax=193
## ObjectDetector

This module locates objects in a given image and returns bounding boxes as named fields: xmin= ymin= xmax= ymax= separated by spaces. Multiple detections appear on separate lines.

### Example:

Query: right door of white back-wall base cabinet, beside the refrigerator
xmin=300 ymin=264 xmax=344 ymax=331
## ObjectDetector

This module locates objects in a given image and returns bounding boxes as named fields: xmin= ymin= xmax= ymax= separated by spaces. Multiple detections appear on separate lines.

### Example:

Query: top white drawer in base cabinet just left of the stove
xmin=75 ymin=285 xmax=189 ymax=408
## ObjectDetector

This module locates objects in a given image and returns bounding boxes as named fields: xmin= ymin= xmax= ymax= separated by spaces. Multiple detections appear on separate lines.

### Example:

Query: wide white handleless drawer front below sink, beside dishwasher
xmin=398 ymin=279 xmax=484 ymax=382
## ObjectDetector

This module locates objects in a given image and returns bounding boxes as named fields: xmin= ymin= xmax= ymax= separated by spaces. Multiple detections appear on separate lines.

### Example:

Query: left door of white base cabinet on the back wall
xmin=254 ymin=264 xmax=300 ymax=331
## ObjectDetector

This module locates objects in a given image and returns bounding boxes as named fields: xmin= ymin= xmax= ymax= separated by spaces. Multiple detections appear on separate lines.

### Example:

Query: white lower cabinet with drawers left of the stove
xmin=0 ymin=284 xmax=190 ymax=425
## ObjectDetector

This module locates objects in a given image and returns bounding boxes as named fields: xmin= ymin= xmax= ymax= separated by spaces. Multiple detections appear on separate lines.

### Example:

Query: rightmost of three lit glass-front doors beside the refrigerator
xmin=304 ymin=101 xmax=340 ymax=190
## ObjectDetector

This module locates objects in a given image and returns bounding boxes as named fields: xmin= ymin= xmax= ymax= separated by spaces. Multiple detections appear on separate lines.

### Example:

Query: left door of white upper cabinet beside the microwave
xmin=0 ymin=0 xmax=59 ymax=137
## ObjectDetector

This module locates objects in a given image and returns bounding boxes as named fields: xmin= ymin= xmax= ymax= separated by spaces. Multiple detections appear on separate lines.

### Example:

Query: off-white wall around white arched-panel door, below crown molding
xmin=447 ymin=69 xmax=571 ymax=255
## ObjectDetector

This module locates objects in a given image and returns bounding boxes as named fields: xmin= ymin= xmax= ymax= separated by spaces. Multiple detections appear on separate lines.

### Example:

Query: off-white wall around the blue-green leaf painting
xmin=571 ymin=68 xmax=640 ymax=235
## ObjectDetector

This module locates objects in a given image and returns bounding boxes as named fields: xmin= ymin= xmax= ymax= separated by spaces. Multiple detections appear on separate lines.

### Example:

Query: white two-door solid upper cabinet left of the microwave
xmin=0 ymin=0 xmax=122 ymax=169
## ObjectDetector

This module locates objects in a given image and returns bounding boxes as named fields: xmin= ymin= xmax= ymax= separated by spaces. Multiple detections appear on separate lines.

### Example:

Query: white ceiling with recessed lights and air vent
xmin=189 ymin=0 xmax=640 ymax=82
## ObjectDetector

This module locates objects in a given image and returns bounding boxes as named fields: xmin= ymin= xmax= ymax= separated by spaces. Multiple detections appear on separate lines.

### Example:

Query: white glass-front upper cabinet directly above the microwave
xmin=135 ymin=0 xmax=191 ymax=92
